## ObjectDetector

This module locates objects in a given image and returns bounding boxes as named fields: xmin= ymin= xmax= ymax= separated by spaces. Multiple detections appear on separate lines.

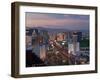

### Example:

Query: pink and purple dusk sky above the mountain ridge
xmin=25 ymin=12 xmax=89 ymax=30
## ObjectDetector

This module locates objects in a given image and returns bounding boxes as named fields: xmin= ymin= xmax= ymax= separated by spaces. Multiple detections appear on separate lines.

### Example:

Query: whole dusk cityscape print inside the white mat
xmin=25 ymin=12 xmax=90 ymax=67
